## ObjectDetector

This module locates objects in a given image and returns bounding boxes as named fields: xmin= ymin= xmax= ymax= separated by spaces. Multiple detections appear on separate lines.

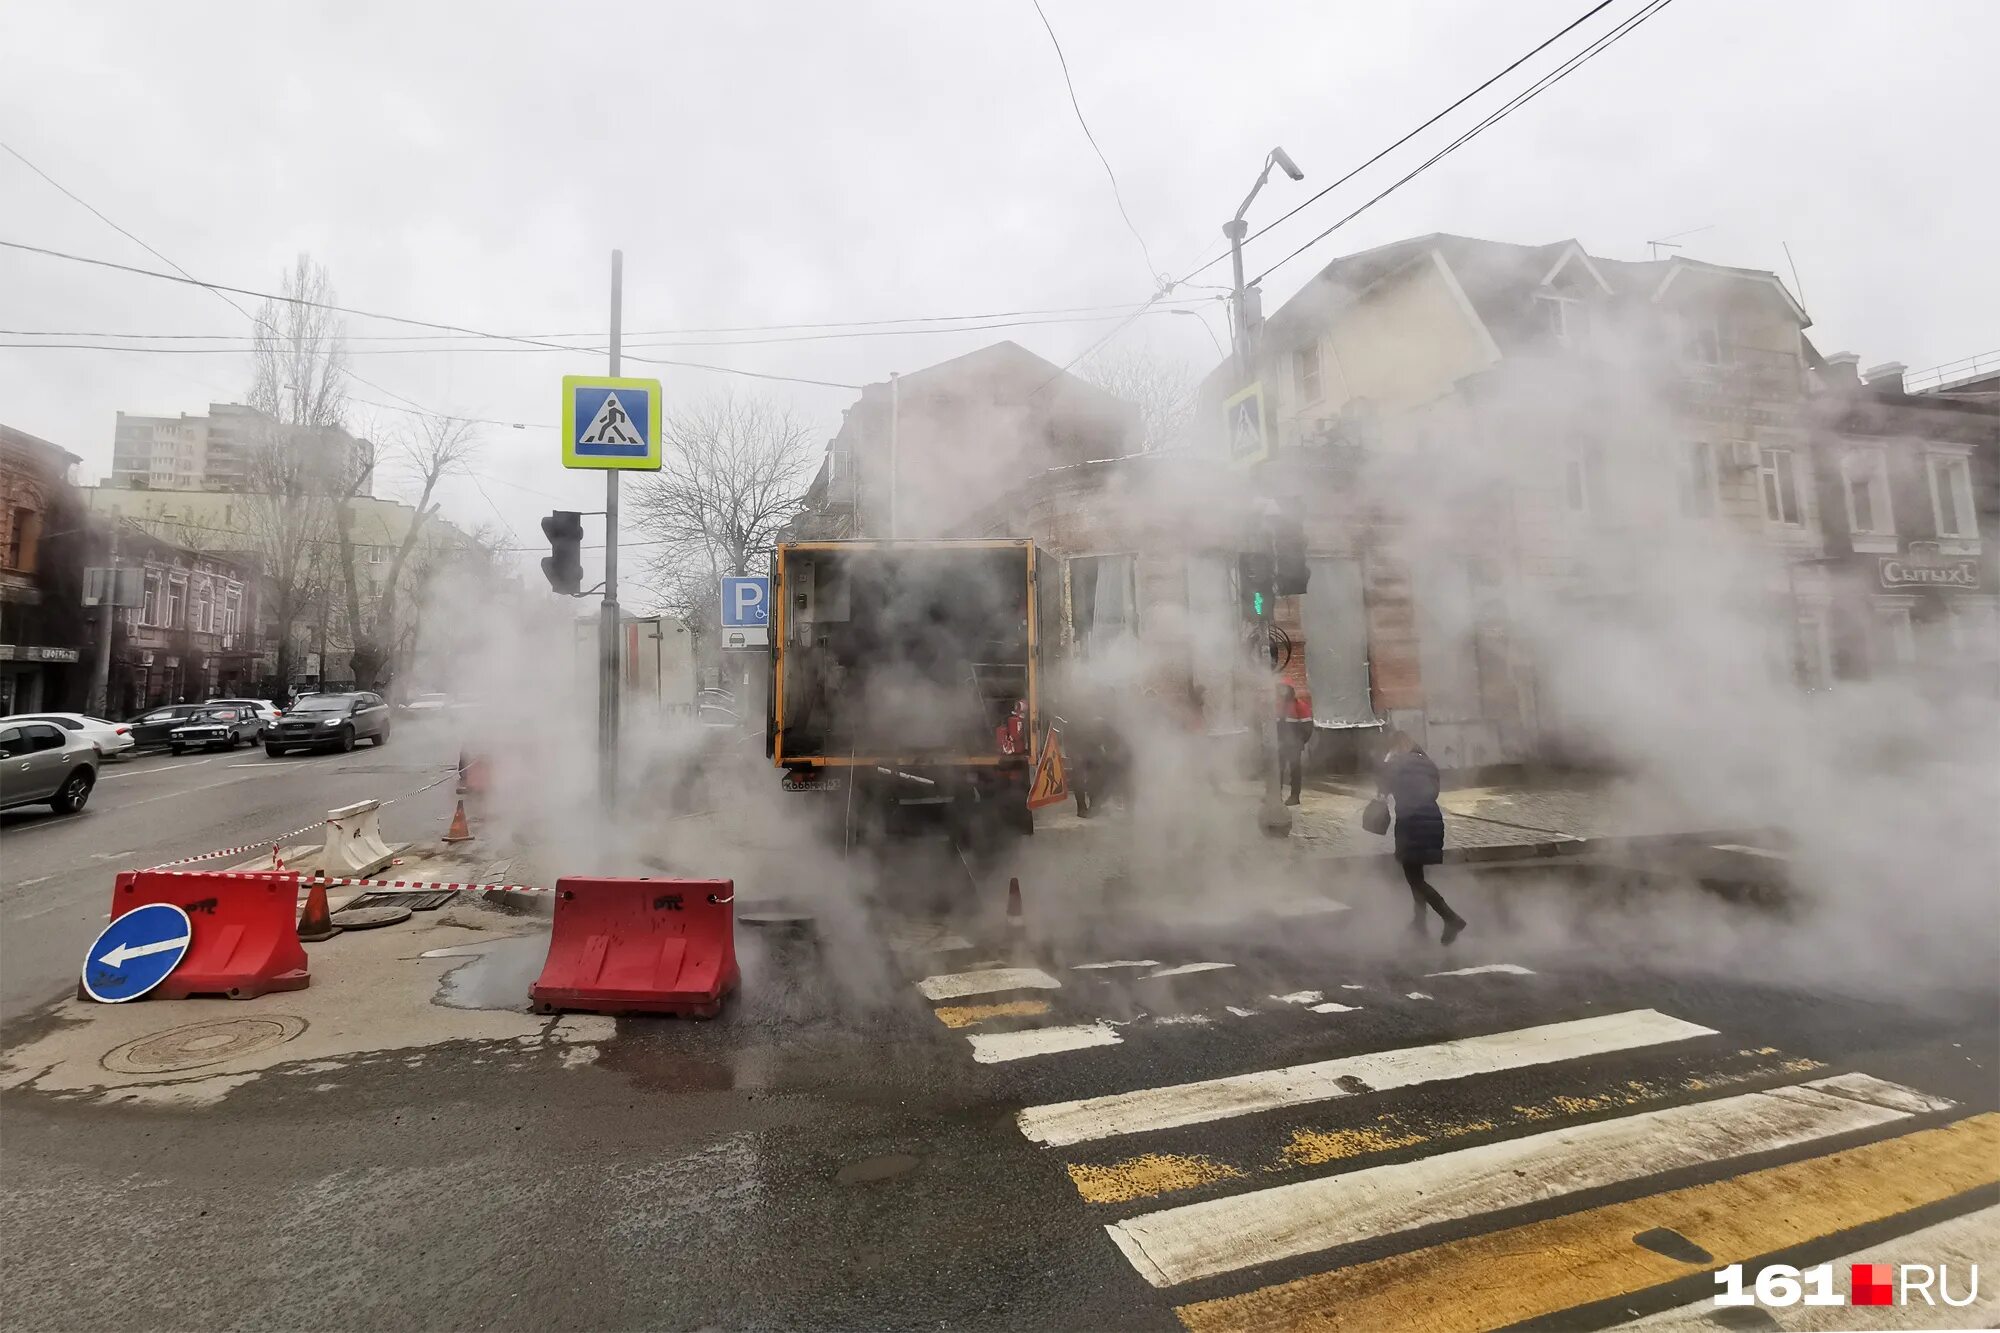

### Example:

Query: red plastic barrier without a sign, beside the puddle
xmin=528 ymin=879 xmax=738 ymax=1019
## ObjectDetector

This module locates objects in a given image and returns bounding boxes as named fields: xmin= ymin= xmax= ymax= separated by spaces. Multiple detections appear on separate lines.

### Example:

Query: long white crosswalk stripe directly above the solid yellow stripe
xmin=1106 ymin=1073 xmax=1952 ymax=1287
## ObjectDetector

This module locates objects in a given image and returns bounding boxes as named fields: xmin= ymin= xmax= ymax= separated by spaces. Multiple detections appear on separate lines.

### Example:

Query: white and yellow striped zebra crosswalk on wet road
xmin=916 ymin=940 xmax=2000 ymax=1333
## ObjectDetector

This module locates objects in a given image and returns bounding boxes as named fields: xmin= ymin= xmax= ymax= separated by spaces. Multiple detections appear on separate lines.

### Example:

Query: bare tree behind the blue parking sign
xmin=632 ymin=384 xmax=820 ymax=586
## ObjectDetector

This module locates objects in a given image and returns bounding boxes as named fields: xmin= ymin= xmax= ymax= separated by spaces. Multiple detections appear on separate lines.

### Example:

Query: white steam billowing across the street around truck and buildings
xmin=414 ymin=352 xmax=2000 ymax=1003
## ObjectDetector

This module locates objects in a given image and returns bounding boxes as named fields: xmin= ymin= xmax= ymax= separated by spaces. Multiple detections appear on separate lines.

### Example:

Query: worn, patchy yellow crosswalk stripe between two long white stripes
xmin=1072 ymin=1048 xmax=1824 ymax=1203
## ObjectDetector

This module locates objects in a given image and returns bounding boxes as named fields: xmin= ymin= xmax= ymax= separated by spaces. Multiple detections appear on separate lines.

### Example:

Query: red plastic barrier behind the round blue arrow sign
xmin=112 ymin=871 xmax=312 ymax=999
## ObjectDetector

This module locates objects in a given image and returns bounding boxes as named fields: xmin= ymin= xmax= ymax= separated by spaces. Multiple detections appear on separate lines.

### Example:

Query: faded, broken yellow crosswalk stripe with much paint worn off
xmin=1070 ymin=1051 xmax=1824 ymax=1203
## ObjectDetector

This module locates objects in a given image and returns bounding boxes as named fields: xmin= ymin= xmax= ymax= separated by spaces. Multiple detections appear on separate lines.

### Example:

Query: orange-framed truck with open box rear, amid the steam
xmin=764 ymin=540 xmax=1046 ymax=833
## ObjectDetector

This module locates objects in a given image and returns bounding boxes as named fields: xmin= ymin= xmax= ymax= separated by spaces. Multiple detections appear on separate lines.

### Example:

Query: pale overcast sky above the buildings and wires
xmin=0 ymin=0 xmax=2000 ymax=592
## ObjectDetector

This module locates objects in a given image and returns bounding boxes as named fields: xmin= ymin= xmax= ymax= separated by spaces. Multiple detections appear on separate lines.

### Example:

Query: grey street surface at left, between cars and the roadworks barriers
xmin=0 ymin=723 xmax=456 ymax=1021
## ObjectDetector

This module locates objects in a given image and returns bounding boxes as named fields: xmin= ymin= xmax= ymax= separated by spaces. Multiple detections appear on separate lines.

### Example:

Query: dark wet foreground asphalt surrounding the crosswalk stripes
xmin=0 ymin=844 xmax=2000 ymax=1329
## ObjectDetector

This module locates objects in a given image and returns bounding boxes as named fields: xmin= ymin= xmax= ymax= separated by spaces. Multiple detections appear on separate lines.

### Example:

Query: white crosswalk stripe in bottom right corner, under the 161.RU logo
xmin=1618 ymin=1207 xmax=2000 ymax=1333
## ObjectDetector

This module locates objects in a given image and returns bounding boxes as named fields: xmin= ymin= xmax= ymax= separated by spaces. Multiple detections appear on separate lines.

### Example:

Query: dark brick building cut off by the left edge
xmin=0 ymin=426 xmax=84 ymax=715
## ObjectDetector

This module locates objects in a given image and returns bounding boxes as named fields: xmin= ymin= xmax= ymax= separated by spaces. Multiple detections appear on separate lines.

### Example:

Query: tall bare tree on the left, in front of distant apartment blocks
xmin=244 ymin=254 xmax=358 ymax=687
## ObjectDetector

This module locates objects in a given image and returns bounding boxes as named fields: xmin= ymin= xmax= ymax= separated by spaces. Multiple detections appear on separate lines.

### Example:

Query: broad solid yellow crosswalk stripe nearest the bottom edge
xmin=1174 ymin=1115 xmax=2000 ymax=1333
